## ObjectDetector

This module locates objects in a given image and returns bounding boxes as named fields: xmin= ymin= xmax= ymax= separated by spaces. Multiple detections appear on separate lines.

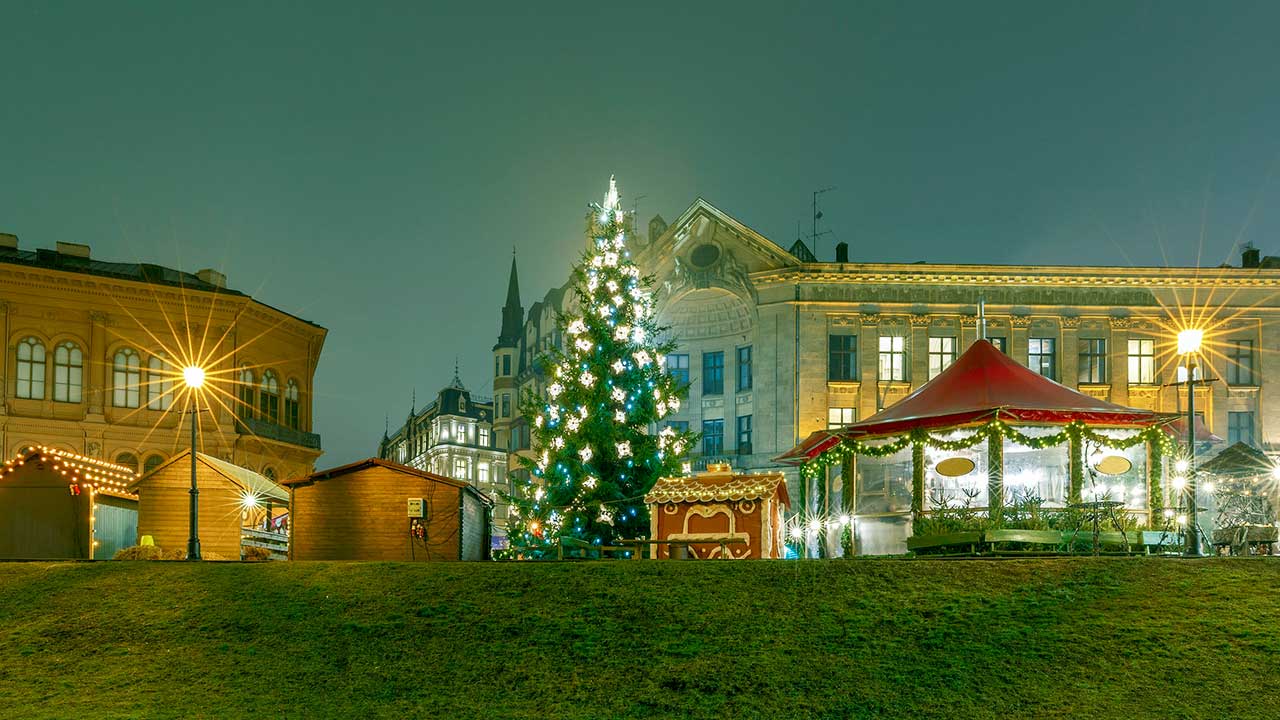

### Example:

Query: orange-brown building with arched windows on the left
xmin=0 ymin=234 xmax=328 ymax=479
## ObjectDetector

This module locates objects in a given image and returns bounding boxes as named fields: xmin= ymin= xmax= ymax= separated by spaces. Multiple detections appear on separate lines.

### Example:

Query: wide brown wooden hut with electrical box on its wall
xmin=284 ymin=457 xmax=493 ymax=562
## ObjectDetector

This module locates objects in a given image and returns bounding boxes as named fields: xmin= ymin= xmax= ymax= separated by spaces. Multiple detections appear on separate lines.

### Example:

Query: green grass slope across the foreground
xmin=0 ymin=559 xmax=1280 ymax=720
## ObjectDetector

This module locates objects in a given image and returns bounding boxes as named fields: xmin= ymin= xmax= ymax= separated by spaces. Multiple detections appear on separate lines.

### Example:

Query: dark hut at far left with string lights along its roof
xmin=0 ymin=447 xmax=138 ymax=560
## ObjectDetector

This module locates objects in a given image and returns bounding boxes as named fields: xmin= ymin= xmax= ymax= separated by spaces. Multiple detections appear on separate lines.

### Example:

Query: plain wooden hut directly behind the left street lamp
xmin=129 ymin=448 xmax=289 ymax=560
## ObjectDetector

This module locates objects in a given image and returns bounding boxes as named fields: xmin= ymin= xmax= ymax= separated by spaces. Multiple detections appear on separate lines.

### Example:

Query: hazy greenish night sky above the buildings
xmin=0 ymin=1 xmax=1280 ymax=468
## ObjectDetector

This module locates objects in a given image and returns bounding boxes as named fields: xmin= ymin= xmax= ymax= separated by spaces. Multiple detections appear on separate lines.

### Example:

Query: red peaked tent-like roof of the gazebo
xmin=778 ymin=340 xmax=1162 ymax=461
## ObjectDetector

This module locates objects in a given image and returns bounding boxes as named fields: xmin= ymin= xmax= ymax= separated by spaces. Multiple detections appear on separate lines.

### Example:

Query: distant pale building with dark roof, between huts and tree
xmin=378 ymin=373 xmax=511 ymax=544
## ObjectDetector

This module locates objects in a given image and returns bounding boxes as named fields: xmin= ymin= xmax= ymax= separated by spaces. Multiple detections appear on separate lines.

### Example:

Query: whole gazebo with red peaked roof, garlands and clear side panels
xmin=778 ymin=340 xmax=1174 ymax=555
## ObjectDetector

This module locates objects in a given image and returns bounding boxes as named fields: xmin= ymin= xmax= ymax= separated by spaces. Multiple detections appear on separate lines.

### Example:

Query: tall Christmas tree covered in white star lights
xmin=508 ymin=178 xmax=696 ymax=556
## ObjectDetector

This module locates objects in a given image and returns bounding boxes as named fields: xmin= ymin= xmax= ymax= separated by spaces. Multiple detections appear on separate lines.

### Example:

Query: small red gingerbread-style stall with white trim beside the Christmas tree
xmin=644 ymin=462 xmax=791 ymax=559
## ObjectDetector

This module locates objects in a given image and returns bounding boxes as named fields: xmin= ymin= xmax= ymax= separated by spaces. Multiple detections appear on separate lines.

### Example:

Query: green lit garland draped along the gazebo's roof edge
xmin=800 ymin=418 xmax=1176 ymax=516
